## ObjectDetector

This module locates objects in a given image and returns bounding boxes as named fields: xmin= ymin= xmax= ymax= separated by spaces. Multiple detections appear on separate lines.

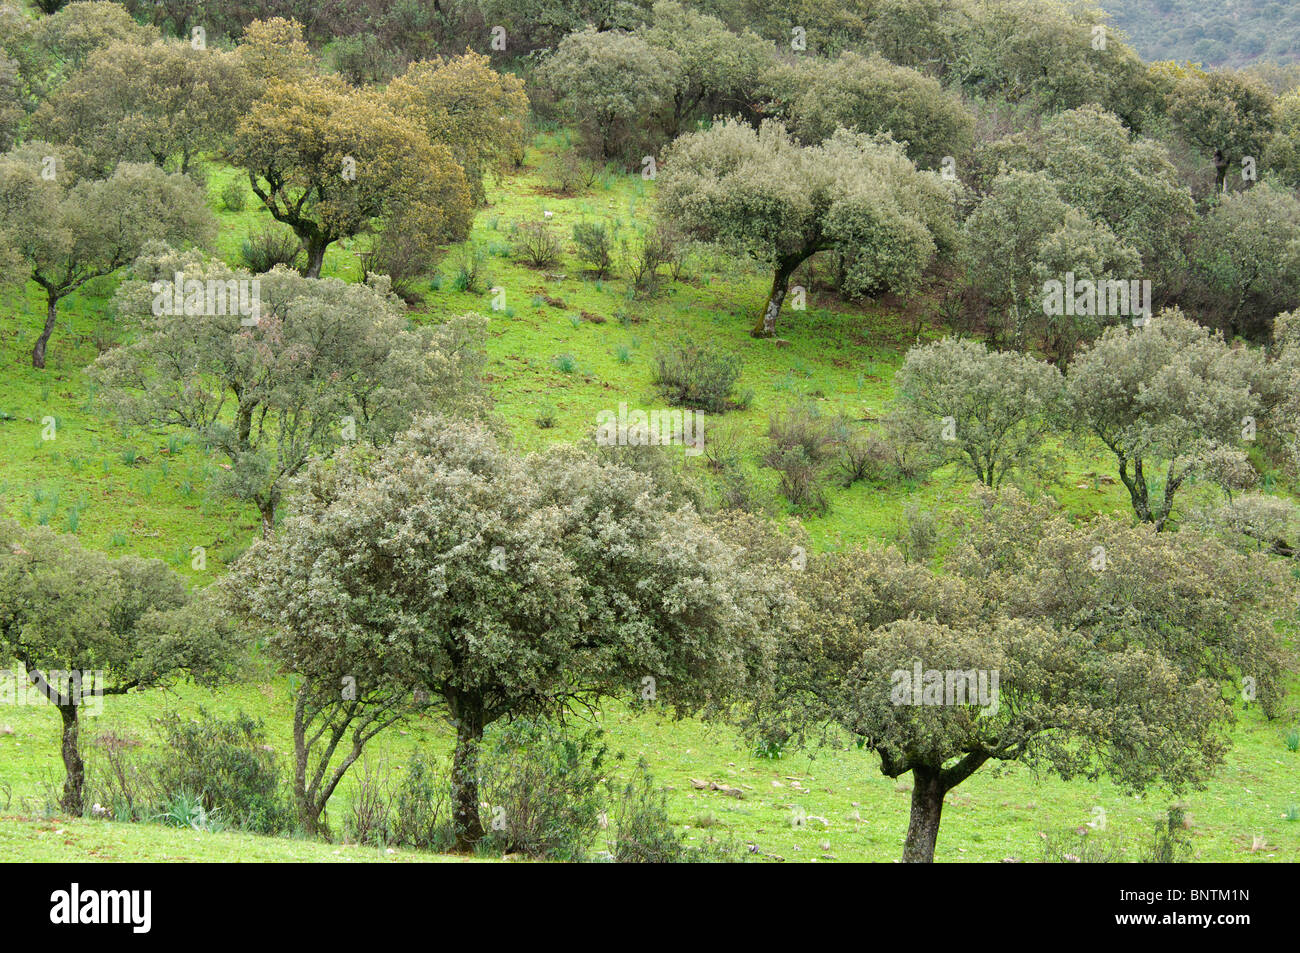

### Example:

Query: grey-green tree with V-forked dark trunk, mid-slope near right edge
xmin=1066 ymin=309 xmax=1264 ymax=529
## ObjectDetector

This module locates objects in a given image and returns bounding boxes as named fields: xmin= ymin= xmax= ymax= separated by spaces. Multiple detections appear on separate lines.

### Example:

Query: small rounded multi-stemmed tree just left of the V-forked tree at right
xmin=894 ymin=338 xmax=1062 ymax=488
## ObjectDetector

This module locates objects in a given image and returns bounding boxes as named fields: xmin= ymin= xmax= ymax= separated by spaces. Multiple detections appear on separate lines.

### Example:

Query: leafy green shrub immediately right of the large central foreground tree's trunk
xmin=478 ymin=719 xmax=607 ymax=861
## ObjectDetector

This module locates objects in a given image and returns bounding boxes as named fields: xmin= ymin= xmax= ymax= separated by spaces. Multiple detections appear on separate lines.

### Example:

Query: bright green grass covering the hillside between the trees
xmin=0 ymin=128 xmax=1300 ymax=861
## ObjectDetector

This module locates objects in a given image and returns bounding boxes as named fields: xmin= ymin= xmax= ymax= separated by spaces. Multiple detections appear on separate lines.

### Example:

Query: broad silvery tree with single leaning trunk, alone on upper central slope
xmin=658 ymin=120 xmax=957 ymax=334
